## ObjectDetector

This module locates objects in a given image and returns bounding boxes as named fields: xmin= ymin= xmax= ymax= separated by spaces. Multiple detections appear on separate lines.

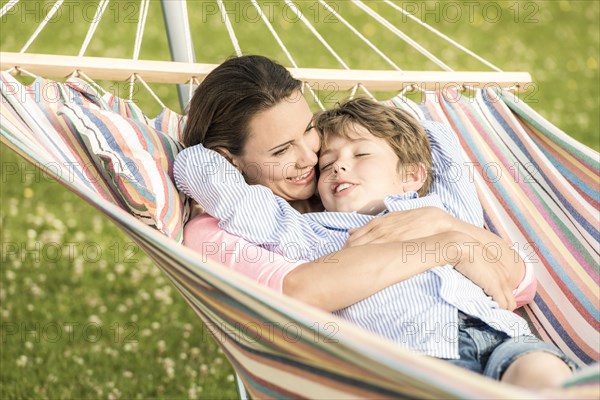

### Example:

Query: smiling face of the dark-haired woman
xmin=233 ymin=93 xmax=320 ymax=201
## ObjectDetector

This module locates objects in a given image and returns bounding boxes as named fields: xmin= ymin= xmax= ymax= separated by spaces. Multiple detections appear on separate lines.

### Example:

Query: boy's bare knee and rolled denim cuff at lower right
xmin=483 ymin=336 xmax=577 ymax=389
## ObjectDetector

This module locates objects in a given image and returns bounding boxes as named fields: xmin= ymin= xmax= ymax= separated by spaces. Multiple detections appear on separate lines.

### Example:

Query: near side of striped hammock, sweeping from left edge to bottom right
xmin=0 ymin=74 xmax=598 ymax=399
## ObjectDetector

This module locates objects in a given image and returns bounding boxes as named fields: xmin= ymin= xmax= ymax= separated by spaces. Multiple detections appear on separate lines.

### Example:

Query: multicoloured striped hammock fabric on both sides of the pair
xmin=1 ymin=74 xmax=600 ymax=399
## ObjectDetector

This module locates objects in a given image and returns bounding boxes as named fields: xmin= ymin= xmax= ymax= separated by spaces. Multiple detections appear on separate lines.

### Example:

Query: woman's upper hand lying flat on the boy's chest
xmin=344 ymin=207 xmax=458 ymax=247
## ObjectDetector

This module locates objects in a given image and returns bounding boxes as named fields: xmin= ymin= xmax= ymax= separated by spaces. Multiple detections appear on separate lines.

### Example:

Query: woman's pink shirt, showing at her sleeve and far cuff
xmin=183 ymin=214 xmax=537 ymax=307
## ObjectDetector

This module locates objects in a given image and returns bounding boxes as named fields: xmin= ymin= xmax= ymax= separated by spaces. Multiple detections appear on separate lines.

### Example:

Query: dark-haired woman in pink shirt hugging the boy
xmin=184 ymin=56 xmax=535 ymax=311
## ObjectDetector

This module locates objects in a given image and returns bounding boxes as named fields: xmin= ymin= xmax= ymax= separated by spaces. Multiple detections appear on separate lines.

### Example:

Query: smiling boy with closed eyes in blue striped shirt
xmin=175 ymin=99 xmax=570 ymax=387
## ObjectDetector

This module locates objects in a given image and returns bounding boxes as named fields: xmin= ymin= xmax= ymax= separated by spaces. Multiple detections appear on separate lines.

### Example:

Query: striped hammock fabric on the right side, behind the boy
xmin=404 ymin=90 xmax=600 ymax=364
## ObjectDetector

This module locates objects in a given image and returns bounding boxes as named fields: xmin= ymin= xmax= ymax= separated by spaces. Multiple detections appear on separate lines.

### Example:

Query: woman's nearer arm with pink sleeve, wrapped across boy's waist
xmin=189 ymin=214 xmax=512 ymax=311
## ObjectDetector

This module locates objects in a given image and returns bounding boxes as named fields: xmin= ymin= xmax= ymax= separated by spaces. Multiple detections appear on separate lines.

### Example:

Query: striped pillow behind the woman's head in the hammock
xmin=59 ymin=104 xmax=189 ymax=243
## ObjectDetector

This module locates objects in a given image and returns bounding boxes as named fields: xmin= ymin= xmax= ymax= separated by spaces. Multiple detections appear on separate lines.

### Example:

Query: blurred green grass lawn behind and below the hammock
xmin=0 ymin=0 xmax=600 ymax=399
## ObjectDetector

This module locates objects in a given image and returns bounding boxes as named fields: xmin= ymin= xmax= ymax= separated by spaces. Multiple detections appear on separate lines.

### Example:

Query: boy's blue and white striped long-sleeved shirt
xmin=174 ymin=121 xmax=530 ymax=358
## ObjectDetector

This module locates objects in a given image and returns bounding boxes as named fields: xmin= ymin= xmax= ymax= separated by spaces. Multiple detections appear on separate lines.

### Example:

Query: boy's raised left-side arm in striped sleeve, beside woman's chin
xmin=174 ymin=145 xmax=322 ymax=254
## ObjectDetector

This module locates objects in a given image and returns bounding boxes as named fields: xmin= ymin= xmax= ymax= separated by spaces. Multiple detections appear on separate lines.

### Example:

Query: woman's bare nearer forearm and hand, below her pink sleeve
xmin=283 ymin=231 xmax=515 ymax=311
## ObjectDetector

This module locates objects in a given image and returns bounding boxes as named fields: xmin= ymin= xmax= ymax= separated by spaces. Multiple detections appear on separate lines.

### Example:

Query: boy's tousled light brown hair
xmin=314 ymin=97 xmax=433 ymax=196
